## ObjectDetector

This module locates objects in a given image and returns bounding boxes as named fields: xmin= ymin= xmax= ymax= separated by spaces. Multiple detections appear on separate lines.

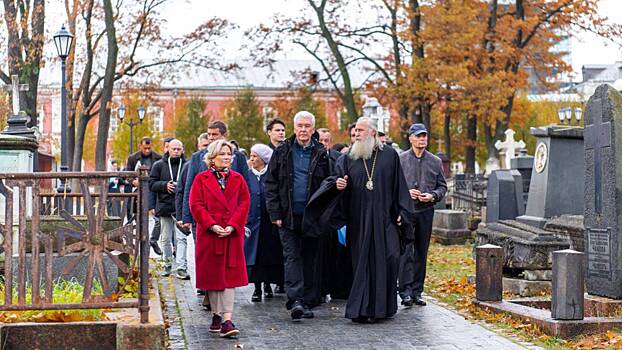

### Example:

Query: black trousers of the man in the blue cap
xmin=399 ymin=208 xmax=434 ymax=298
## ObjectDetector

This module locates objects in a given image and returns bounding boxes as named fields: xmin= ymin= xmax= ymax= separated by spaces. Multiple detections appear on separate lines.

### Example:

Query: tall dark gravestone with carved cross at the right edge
xmin=584 ymin=85 xmax=622 ymax=299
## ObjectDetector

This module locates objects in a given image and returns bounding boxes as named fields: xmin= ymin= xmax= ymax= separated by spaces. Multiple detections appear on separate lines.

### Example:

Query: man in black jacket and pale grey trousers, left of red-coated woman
xmin=149 ymin=140 xmax=190 ymax=279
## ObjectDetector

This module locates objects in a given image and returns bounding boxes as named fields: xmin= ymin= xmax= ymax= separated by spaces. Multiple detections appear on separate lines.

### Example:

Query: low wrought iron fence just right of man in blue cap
xmin=450 ymin=174 xmax=488 ymax=215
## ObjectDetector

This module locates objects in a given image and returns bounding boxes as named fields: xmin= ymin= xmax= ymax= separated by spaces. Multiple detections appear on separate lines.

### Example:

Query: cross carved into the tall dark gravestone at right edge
xmin=583 ymin=99 xmax=611 ymax=214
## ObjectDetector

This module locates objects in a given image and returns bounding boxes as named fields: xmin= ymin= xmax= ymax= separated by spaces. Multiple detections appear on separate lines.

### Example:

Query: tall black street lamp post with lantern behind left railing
xmin=54 ymin=25 xmax=73 ymax=192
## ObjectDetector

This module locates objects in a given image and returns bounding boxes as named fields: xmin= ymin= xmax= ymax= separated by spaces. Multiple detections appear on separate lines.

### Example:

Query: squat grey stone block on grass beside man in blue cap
xmin=432 ymin=209 xmax=471 ymax=245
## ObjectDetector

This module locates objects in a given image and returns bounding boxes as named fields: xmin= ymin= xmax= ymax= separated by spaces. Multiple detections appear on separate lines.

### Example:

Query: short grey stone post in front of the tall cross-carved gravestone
xmin=551 ymin=249 xmax=583 ymax=320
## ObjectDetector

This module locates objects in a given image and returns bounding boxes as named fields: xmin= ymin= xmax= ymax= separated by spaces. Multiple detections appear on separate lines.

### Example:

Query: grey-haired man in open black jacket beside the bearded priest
xmin=266 ymin=111 xmax=330 ymax=321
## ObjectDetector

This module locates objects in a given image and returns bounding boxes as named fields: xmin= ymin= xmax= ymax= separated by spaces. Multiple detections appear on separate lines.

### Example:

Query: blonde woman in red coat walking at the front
xmin=190 ymin=140 xmax=250 ymax=337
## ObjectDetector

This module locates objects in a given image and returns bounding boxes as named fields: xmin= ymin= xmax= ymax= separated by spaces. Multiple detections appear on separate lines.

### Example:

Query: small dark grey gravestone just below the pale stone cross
xmin=486 ymin=170 xmax=525 ymax=223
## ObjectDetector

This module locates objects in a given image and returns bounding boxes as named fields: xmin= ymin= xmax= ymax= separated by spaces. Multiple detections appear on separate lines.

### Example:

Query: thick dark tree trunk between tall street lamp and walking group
xmin=95 ymin=0 xmax=119 ymax=171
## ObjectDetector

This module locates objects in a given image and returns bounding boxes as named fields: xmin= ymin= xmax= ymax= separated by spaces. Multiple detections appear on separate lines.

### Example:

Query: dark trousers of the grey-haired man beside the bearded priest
xmin=279 ymin=215 xmax=319 ymax=309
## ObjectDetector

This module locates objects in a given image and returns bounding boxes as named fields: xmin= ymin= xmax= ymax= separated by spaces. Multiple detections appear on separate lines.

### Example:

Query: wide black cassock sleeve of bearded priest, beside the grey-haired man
xmin=303 ymin=154 xmax=348 ymax=237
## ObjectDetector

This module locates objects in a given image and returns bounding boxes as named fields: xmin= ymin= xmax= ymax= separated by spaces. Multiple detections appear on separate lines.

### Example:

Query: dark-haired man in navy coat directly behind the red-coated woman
xmin=178 ymin=120 xmax=248 ymax=229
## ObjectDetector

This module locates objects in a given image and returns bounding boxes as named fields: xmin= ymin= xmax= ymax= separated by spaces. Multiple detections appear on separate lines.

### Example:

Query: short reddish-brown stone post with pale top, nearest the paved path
xmin=475 ymin=244 xmax=503 ymax=301
